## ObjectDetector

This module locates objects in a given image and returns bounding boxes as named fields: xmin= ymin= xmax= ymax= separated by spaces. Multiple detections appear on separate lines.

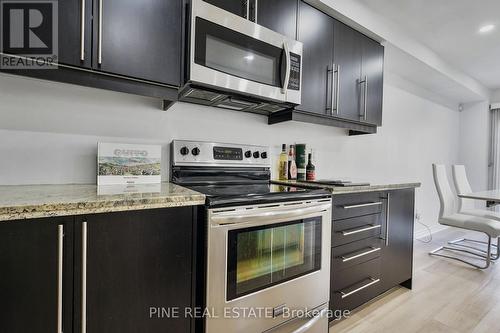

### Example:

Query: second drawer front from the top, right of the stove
xmin=332 ymin=214 xmax=383 ymax=247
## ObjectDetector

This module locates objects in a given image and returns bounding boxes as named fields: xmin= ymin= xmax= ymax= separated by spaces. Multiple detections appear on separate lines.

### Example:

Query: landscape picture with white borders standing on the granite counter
xmin=97 ymin=142 xmax=161 ymax=185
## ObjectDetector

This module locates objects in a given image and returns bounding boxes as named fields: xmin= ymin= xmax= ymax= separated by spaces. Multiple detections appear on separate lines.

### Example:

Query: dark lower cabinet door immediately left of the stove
xmin=75 ymin=207 xmax=193 ymax=333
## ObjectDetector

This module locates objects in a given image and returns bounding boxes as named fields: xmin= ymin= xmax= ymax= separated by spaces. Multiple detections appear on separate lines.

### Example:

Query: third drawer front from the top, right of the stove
xmin=331 ymin=237 xmax=382 ymax=275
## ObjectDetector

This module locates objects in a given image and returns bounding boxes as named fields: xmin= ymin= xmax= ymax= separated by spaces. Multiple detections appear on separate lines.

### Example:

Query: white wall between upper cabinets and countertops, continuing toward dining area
xmin=0 ymin=75 xmax=459 ymax=232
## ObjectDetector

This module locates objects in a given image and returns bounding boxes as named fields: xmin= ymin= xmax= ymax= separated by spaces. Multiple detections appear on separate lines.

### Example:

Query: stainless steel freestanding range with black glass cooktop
xmin=171 ymin=141 xmax=331 ymax=333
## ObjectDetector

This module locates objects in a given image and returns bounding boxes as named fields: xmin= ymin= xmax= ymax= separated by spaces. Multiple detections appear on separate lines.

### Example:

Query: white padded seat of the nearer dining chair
xmin=439 ymin=214 xmax=500 ymax=238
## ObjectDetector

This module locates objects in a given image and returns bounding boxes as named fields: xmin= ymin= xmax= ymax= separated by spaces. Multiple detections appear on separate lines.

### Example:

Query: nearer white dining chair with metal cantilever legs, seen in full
xmin=429 ymin=164 xmax=500 ymax=269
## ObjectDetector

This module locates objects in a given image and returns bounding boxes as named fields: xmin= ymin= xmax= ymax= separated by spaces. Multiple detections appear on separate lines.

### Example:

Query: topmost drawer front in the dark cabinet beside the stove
xmin=332 ymin=192 xmax=384 ymax=220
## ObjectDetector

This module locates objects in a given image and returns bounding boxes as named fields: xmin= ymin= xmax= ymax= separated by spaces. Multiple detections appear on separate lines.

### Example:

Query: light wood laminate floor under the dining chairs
xmin=330 ymin=228 xmax=500 ymax=333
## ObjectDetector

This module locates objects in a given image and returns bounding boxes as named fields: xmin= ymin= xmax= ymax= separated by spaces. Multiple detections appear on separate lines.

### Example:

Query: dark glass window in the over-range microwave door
xmin=195 ymin=18 xmax=284 ymax=87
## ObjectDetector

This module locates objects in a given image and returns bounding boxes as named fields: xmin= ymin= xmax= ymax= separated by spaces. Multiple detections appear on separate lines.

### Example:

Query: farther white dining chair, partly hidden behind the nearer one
xmin=454 ymin=165 xmax=500 ymax=260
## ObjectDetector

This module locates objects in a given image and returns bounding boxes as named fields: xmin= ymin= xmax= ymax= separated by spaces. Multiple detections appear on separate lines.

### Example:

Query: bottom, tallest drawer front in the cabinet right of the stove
xmin=330 ymin=258 xmax=381 ymax=319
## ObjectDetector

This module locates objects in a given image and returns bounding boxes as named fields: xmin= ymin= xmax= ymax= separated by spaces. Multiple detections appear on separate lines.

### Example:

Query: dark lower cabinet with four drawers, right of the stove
xmin=330 ymin=188 xmax=415 ymax=322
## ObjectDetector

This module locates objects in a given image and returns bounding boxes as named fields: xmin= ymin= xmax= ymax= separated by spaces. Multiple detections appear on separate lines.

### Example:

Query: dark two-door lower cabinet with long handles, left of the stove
xmin=0 ymin=207 xmax=196 ymax=333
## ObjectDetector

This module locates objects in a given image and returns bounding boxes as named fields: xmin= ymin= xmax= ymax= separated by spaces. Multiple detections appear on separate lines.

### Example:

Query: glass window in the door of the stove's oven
xmin=227 ymin=217 xmax=321 ymax=300
